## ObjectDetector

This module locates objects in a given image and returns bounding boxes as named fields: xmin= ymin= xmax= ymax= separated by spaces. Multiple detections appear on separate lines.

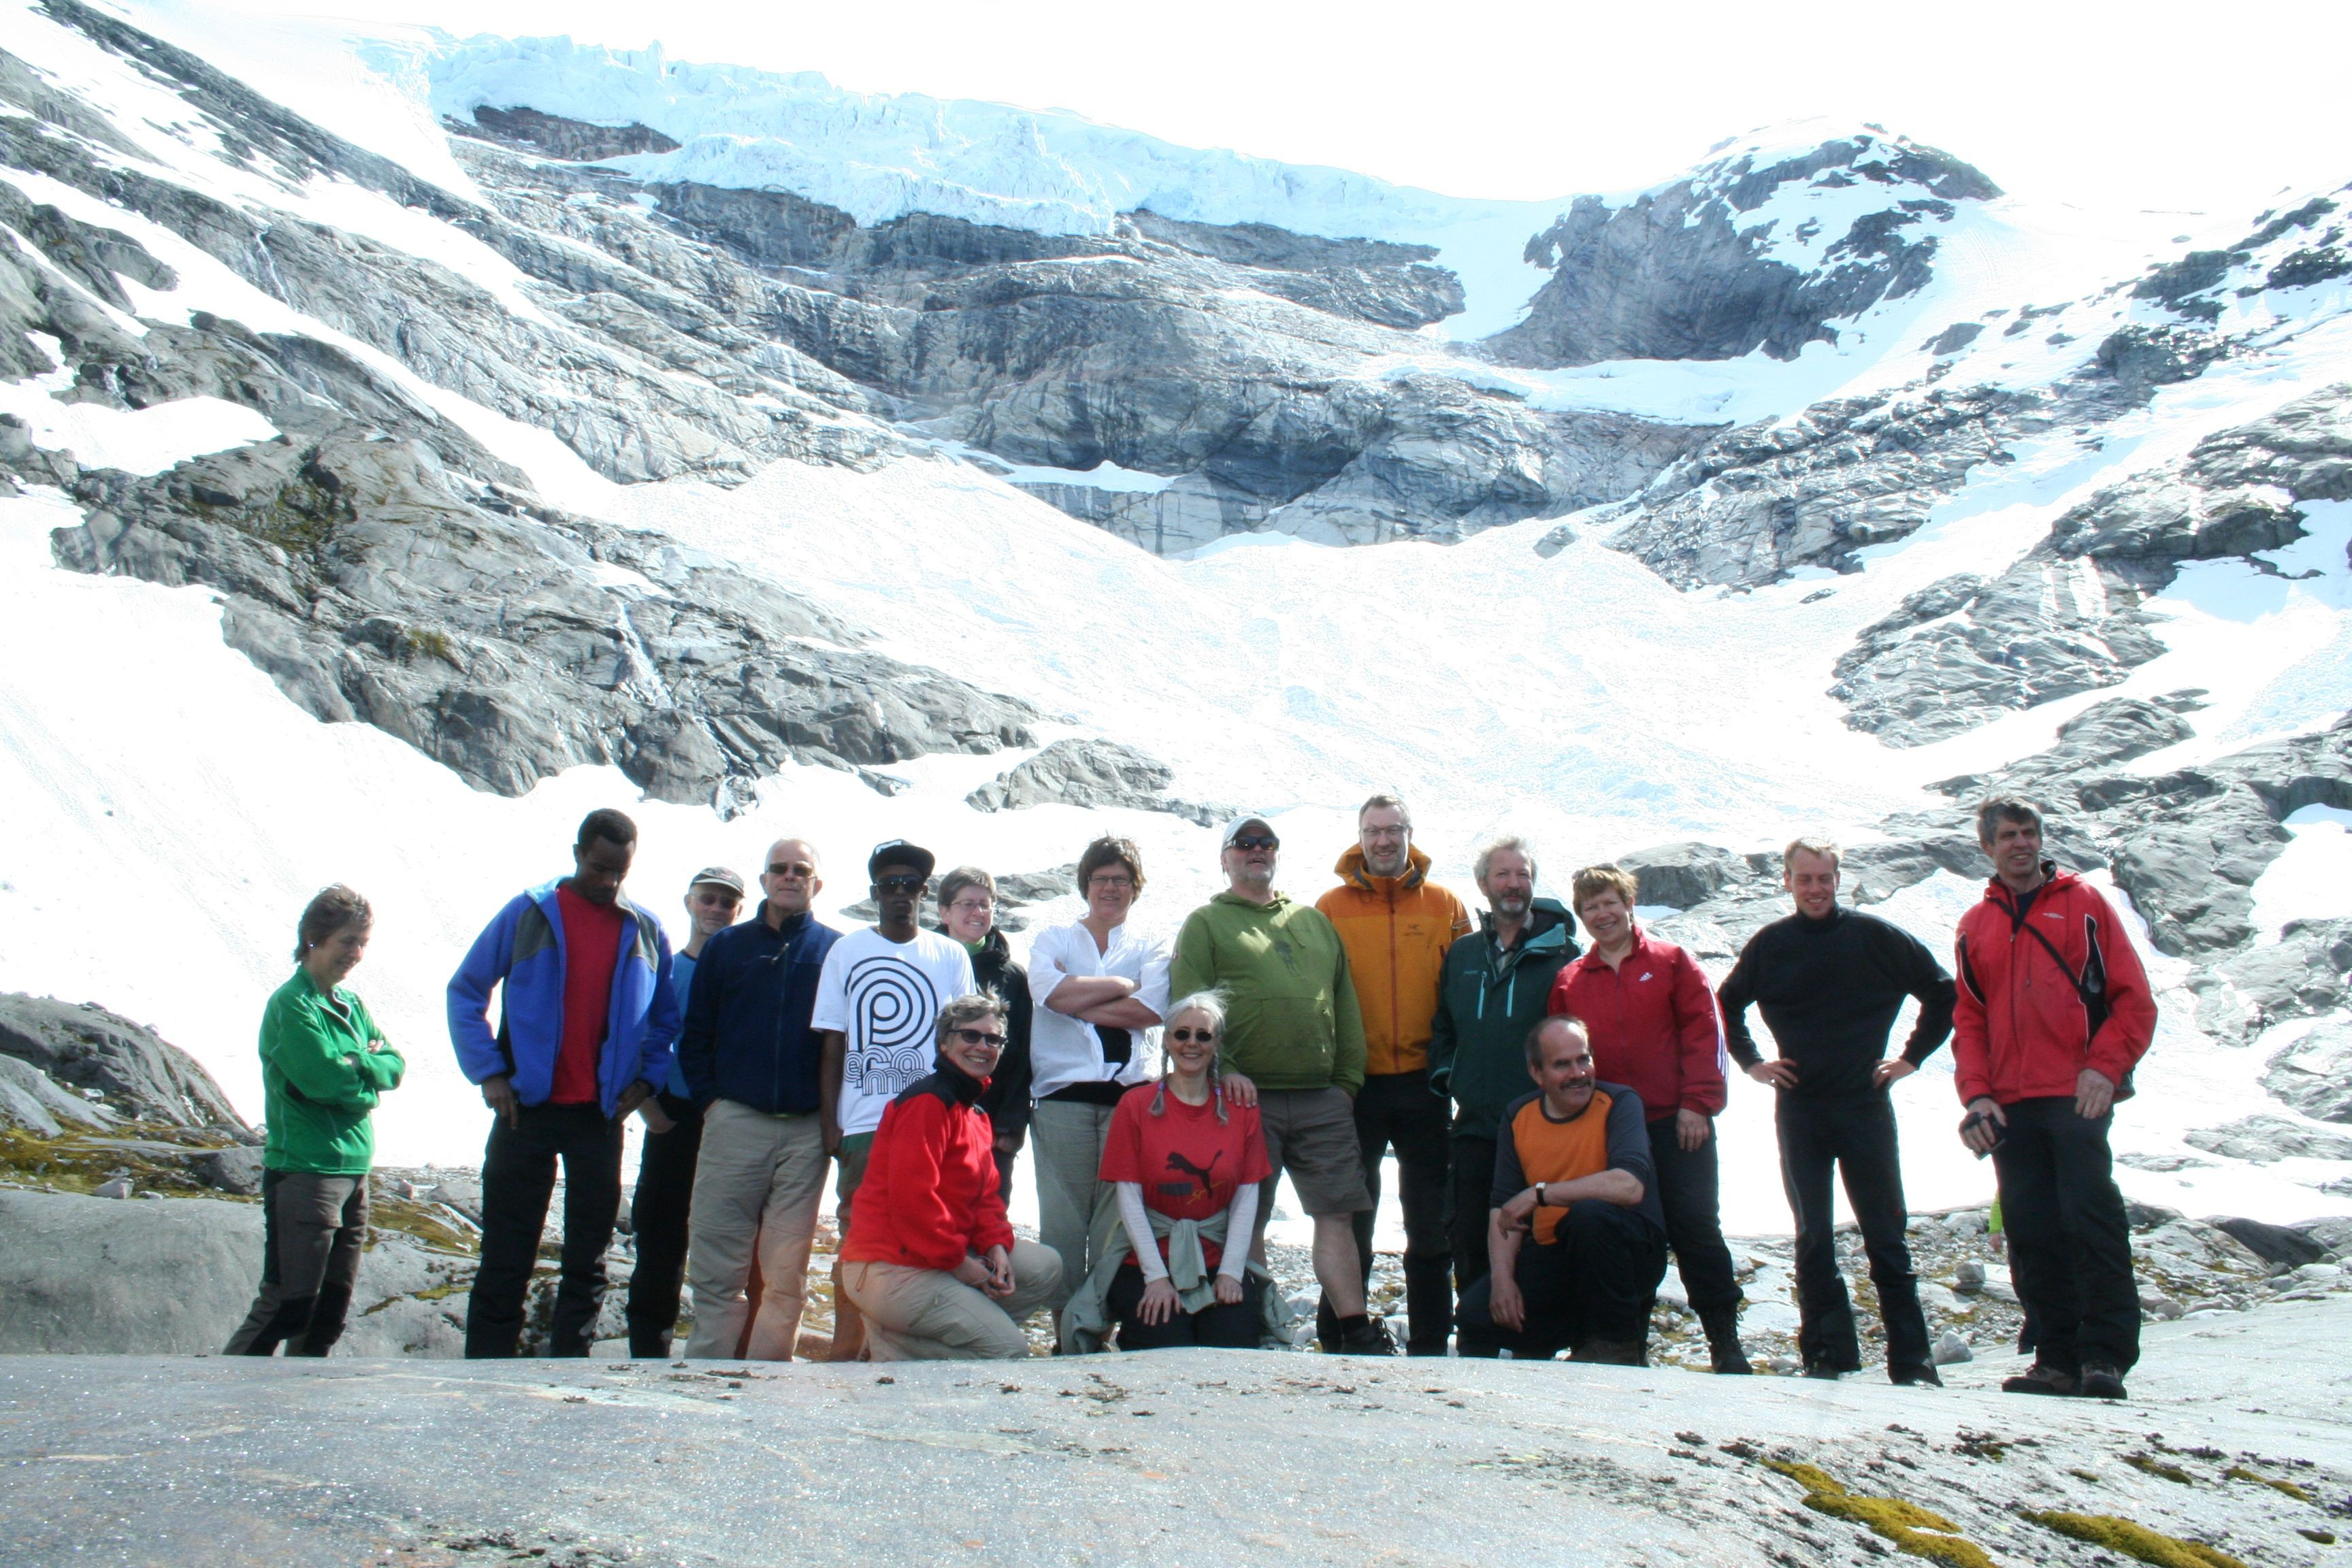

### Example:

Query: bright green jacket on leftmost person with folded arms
xmin=261 ymin=968 xmax=407 ymax=1175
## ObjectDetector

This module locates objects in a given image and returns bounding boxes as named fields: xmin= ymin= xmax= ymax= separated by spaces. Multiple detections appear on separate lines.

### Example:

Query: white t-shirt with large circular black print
xmin=809 ymin=926 xmax=979 ymax=1133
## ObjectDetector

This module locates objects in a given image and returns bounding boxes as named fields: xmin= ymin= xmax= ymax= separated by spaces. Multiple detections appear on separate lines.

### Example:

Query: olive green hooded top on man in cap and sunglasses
xmin=1169 ymin=894 xmax=1364 ymax=1093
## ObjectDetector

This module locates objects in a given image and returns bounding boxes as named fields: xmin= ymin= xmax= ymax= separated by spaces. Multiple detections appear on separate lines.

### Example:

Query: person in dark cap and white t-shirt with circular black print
xmin=809 ymin=839 xmax=974 ymax=1361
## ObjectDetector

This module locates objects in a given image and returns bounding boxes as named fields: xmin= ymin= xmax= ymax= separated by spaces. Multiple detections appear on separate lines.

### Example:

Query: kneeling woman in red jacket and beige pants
xmin=842 ymin=994 xmax=1061 ymax=1361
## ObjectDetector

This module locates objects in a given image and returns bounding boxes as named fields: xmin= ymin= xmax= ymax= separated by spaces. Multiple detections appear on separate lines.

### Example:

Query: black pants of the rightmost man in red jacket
xmin=1992 ymin=1096 xmax=2140 ymax=1375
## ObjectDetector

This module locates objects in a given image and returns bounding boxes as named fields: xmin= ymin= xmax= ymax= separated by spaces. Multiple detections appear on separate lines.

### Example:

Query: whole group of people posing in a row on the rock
xmin=231 ymin=795 xmax=2155 ymax=1399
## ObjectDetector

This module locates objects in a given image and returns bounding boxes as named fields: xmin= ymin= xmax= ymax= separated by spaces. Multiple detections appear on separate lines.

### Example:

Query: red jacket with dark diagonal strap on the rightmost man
xmin=1952 ymin=863 xmax=2157 ymax=1105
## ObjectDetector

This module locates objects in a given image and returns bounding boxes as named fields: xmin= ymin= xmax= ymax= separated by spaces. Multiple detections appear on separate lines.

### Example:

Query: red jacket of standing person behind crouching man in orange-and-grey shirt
xmin=1552 ymin=924 xmax=1729 ymax=1122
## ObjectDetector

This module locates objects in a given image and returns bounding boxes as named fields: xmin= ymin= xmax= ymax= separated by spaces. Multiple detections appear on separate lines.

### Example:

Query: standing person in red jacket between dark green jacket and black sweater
xmin=1552 ymin=865 xmax=1750 ymax=1373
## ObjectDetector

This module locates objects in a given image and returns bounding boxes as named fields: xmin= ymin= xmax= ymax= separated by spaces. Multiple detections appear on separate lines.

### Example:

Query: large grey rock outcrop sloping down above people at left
xmin=56 ymin=425 xmax=1030 ymax=802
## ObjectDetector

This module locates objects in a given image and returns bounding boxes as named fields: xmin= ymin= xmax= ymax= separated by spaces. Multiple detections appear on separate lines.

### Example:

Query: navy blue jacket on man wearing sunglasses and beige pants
xmin=677 ymin=902 xmax=842 ymax=1117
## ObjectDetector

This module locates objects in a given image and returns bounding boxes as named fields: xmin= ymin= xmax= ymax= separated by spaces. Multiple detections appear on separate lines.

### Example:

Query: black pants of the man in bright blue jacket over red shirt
xmin=466 ymin=1105 xmax=621 ymax=1359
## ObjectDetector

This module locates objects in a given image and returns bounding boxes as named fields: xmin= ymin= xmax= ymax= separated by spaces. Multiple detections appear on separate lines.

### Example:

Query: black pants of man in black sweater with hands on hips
xmin=1774 ymin=1093 xmax=1929 ymax=1373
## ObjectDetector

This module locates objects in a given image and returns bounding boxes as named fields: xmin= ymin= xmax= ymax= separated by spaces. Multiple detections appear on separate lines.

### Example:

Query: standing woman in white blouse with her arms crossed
xmin=1028 ymin=839 xmax=1169 ymax=1319
